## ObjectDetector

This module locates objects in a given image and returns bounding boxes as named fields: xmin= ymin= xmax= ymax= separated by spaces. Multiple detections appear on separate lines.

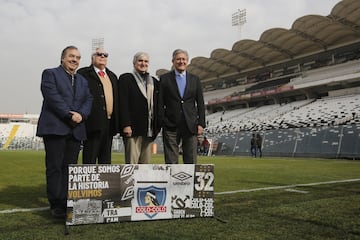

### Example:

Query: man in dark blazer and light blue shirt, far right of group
xmin=159 ymin=49 xmax=205 ymax=164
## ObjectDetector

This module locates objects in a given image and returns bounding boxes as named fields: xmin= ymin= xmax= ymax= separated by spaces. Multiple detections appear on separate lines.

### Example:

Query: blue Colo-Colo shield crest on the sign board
xmin=135 ymin=186 xmax=166 ymax=218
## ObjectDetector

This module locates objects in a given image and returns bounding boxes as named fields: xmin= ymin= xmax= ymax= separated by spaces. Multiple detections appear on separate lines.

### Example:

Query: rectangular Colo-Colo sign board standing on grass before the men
xmin=66 ymin=164 xmax=214 ymax=226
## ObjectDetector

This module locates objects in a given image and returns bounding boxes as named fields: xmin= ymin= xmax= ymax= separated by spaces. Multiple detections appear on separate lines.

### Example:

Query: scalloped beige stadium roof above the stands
xmin=156 ymin=0 xmax=360 ymax=82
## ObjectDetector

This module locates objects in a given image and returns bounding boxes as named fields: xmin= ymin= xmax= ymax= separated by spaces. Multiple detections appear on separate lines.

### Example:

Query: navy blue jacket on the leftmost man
xmin=36 ymin=66 xmax=93 ymax=141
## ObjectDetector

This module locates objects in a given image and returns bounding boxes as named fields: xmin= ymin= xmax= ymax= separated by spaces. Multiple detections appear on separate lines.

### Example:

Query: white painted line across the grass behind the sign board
xmin=0 ymin=178 xmax=360 ymax=214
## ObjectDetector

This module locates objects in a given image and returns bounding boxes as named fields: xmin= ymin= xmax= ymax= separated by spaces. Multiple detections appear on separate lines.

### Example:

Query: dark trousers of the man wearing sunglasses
xmin=83 ymin=122 xmax=113 ymax=164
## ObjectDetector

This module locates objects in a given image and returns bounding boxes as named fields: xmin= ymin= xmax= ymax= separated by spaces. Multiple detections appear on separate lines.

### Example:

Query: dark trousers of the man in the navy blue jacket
xmin=43 ymin=135 xmax=80 ymax=209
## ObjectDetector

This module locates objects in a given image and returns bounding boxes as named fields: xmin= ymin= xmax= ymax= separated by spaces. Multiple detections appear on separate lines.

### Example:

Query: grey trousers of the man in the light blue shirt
xmin=163 ymin=128 xmax=197 ymax=164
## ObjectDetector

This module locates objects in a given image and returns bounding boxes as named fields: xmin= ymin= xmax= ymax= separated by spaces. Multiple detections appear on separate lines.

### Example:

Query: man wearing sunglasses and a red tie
xmin=78 ymin=48 xmax=118 ymax=164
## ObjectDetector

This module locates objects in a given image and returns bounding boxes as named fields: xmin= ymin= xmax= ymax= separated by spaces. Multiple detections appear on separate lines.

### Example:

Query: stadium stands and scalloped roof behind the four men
xmin=0 ymin=0 xmax=360 ymax=159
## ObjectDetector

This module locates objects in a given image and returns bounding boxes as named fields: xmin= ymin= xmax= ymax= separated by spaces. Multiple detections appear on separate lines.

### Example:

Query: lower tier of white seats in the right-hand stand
xmin=206 ymin=94 xmax=360 ymax=134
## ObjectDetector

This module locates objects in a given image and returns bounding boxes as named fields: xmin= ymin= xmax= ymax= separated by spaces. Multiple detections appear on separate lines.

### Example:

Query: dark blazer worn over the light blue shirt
xmin=159 ymin=71 xmax=205 ymax=134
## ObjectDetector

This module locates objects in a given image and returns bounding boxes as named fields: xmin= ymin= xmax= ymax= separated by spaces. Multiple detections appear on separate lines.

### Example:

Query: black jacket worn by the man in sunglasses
xmin=77 ymin=65 xmax=119 ymax=136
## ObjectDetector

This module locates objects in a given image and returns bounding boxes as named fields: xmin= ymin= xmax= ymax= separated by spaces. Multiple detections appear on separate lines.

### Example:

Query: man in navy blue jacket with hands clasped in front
xmin=36 ymin=46 xmax=93 ymax=218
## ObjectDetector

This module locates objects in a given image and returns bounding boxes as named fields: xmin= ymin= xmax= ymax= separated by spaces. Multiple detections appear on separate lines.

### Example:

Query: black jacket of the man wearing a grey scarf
xmin=118 ymin=73 xmax=160 ymax=139
